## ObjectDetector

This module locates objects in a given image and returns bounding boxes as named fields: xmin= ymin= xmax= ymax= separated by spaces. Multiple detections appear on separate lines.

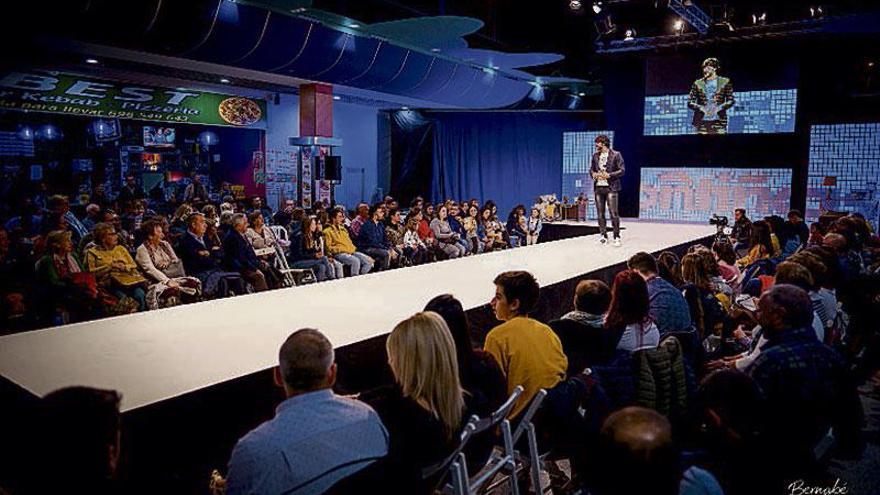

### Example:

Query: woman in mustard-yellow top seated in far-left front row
xmin=85 ymin=222 xmax=147 ymax=313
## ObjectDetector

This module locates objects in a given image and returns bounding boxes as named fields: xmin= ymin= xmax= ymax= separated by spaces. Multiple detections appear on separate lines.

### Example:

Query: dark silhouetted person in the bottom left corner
xmin=33 ymin=387 xmax=124 ymax=494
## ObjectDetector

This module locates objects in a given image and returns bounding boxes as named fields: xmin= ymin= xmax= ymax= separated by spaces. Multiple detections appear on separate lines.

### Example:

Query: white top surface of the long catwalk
xmin=0 ymin=222 xmax=714 ymax=410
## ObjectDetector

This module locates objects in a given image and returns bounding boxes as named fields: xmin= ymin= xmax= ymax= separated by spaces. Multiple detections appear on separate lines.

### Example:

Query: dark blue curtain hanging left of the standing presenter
xmin=429 ymin=112 xmax=596 ymax=217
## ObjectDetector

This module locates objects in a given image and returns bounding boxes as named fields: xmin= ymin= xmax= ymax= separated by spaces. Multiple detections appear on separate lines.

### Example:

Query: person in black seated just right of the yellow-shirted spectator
xmin=549 ymin=280 xmax=617 ymax=376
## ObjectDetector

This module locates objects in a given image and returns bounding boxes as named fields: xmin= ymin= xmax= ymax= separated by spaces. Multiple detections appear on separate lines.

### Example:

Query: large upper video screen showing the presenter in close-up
xmin=644 ymin=52 xmax=798 ymax=136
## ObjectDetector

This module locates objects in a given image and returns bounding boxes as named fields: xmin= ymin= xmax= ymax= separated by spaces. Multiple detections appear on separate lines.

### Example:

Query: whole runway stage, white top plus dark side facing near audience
xmin=0 ymin=223 xmax=714 ymax=493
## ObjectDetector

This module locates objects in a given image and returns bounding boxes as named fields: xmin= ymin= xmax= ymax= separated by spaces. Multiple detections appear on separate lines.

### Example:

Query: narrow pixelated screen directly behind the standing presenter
xmin=559 ymin=131 xmax=612 ymax=218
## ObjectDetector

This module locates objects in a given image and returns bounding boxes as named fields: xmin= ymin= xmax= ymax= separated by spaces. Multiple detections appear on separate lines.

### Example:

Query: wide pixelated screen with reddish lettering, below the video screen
xmin=639 ymin=167 xmax=792 ymax=223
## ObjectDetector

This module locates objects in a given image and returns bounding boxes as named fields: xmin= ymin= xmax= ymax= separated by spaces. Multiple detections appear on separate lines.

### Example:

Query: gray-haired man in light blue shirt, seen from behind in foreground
xmin=226 ymin=328 xmax=388 ymax=495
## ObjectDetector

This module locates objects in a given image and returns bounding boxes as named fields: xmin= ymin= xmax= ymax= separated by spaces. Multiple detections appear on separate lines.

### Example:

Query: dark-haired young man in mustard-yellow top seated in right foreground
xmin=485 ymin=271 xmax=568 ymax=418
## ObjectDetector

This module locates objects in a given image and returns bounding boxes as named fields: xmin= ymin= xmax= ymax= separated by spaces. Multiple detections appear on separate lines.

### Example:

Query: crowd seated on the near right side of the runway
xmin=15 ymin=205 xmax=880 ymax=495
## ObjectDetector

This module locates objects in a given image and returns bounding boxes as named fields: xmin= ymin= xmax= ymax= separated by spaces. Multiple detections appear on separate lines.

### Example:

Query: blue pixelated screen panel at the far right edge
xmin=805 ymin=123 xmax=880 ymax=229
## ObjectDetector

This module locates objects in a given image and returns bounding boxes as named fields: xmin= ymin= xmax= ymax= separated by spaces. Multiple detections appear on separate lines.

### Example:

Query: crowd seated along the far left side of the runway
xmin=0 ymin=176 xmax=542 ymax=333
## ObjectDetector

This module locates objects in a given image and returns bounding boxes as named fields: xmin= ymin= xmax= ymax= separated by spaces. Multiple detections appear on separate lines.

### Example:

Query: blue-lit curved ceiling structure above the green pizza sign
xmin=31 ymin=0 xmax=588 ymax=108
